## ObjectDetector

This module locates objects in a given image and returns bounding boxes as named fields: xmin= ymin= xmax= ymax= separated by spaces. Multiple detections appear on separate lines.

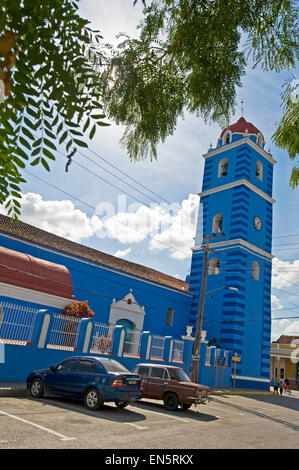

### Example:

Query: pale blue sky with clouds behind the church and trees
xmin=2 ymin=0 xmax=299 ymax=340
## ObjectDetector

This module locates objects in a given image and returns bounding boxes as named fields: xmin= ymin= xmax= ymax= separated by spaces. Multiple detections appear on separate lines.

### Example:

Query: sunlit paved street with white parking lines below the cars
xmin=0 ymin=387 xmax=299 ymax=449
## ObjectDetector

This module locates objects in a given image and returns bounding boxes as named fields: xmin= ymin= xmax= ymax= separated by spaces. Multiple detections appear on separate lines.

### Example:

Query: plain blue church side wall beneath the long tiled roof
xmin=0 ymin=234 xmax=192 ymax=338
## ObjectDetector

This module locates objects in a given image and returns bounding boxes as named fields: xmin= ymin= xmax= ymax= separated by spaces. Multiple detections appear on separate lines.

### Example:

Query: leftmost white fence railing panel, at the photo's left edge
xmin=0 ymin=302 xmax=38 ymax=343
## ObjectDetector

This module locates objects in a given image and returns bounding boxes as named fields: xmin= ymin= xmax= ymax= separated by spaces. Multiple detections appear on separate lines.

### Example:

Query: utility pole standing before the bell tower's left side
xmin=191 ymin=232 xmax=225 ymax=383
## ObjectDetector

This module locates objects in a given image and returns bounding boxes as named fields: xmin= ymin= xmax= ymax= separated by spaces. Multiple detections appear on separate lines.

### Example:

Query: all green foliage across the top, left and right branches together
xmin=0 ymin=0 xmax=299 ymax=216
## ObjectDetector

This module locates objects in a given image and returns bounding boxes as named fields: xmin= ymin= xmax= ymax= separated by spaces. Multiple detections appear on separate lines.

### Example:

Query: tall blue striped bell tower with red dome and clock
xmin=190 ymin=117 xmax=276 ymax=389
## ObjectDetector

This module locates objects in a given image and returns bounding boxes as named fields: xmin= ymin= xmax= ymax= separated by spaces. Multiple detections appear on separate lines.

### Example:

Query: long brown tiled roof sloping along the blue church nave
xmin=0 ymin=214 xmax=188 ymax=292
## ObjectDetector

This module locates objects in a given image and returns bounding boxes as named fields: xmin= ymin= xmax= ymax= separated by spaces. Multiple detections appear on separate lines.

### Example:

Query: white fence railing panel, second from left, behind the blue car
xmin=47 ymin=313 xmax=80 ymax=350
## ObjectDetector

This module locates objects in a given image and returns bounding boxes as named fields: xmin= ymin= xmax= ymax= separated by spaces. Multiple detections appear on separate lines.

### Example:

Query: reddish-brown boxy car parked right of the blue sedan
xmin=133 ymin=364 xmax=211 ymax=410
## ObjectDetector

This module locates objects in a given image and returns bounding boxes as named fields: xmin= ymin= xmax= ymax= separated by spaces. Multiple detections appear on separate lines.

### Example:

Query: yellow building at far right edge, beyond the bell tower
xmin=270 ymin=335 xmax=299 ymax=389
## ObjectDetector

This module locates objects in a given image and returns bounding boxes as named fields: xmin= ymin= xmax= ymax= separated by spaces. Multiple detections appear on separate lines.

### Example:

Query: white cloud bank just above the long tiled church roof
xmin=1 ymin=193 xmax=199 ymax=260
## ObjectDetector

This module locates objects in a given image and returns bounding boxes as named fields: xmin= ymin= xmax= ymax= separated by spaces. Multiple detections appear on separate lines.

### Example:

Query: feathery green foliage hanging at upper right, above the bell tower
xmin=100 ymin=0 xmax=299 ymax=180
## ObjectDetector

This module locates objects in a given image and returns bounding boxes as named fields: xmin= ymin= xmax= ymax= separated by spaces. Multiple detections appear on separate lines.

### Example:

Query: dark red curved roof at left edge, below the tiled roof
xmin=0 ymin=246 xmax=73 ymax=300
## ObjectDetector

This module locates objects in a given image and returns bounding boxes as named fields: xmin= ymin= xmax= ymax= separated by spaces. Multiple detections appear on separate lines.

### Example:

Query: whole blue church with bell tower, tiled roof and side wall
xmin=0 ymin=117 xmax=275 ymax=388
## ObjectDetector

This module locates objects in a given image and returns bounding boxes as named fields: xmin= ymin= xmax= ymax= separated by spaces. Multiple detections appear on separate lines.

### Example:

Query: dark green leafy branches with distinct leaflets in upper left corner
xmin=0 ymin=0 xmax=105 ymax=216
